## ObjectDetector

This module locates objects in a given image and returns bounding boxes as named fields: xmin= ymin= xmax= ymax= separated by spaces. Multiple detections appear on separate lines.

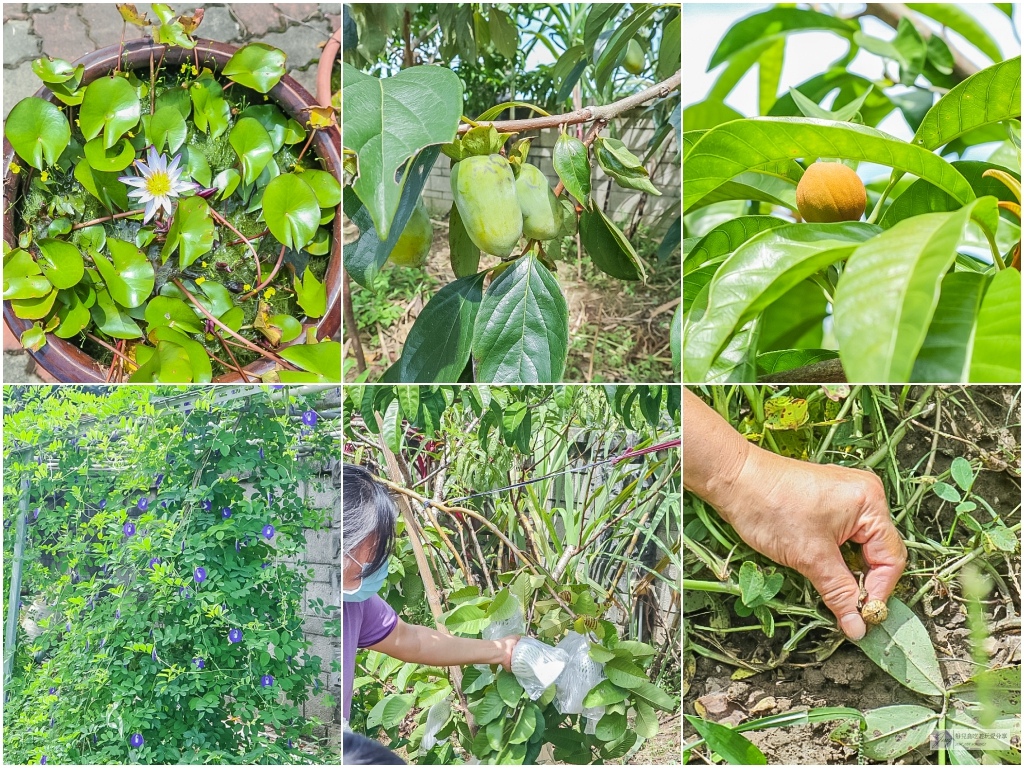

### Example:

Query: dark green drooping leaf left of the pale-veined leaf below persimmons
xmin=398 ymin=272 xmax=485 ymax=383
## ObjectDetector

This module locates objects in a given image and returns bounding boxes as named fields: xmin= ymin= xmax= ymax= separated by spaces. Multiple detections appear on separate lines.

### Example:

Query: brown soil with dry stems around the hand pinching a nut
xmin=684 ymin=387 xmax=1021 ymax=765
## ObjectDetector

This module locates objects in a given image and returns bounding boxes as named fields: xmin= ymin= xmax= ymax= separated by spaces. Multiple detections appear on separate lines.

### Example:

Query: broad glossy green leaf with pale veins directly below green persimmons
xmin=473 ymin=255 xmax=568 ymax=383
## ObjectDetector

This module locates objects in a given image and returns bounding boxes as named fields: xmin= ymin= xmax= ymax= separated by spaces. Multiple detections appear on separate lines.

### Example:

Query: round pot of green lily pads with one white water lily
xmin=3 ymin=3 xmax=341 ymax=382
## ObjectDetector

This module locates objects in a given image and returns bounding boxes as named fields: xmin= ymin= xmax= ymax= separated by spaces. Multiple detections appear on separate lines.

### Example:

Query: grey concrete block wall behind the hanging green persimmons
xmin=423 ymin=121 xmax=682 ymax=234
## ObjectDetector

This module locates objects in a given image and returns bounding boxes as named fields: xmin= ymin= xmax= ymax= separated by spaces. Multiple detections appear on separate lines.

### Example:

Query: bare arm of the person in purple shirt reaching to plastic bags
xmin=370 ymin=620 xmax=519 ymax=670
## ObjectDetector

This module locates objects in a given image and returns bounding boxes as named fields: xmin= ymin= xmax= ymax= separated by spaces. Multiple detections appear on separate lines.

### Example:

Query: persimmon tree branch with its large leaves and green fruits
xmin=343 ymin=4 xmax=681 ymax=383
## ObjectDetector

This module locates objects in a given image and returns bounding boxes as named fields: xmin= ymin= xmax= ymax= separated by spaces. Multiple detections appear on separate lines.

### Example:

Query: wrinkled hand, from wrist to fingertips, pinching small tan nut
xmin=708 ymin=445 xmax=906 ymax=640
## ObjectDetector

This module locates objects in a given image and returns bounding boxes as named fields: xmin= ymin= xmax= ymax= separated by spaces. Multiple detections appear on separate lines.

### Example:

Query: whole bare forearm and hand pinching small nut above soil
xmin=683 ymin=388 xmax=906 ymax=640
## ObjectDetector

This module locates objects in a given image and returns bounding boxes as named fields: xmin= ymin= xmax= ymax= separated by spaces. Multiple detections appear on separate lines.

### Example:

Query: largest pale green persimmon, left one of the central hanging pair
xmin=452 ymin=155 xmax=522 ymax=258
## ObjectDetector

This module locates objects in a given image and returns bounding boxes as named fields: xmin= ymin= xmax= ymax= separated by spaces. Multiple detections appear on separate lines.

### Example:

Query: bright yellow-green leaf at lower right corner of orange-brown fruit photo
xmin=970 ymin=267 xmax=1021 ymax=383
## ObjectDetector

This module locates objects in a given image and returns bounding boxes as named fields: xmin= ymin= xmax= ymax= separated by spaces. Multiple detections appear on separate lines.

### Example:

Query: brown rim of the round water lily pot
xmin=3 ymin=39 xmax=341 ymax=382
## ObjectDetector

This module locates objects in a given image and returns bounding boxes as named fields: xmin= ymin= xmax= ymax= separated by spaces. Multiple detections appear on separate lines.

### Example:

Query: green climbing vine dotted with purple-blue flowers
xmin=3 ymin=387 xmax=340 ymax=765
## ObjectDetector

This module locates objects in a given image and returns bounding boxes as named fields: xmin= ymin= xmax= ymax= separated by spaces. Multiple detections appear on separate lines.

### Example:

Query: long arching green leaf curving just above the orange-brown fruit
xmin=683 ymin=118 xmax=975 ymax=211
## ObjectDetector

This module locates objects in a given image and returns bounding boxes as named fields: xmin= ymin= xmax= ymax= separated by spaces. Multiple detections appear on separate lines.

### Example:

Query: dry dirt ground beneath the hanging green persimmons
xmin=345 ymin=211 xmax=680 ymax=382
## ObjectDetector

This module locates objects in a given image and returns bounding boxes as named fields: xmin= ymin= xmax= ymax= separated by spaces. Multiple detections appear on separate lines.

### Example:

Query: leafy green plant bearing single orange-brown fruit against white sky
xmin=682 ymin=3 xmax=1021 ymax=382
